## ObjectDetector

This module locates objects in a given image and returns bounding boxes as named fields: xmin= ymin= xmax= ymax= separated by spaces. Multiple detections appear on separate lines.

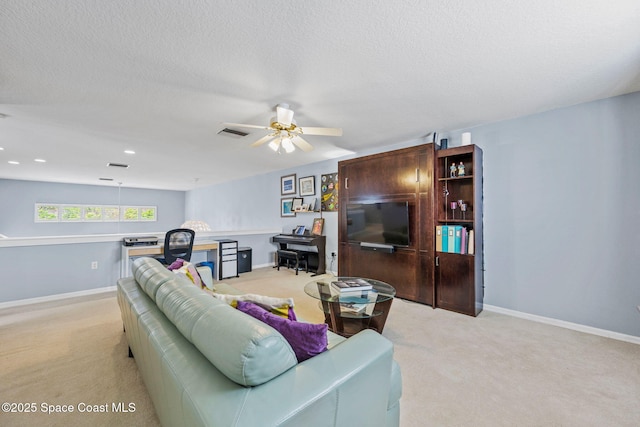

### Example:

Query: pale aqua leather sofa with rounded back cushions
xmin=117 ymin=258 xmax=402 ymax=427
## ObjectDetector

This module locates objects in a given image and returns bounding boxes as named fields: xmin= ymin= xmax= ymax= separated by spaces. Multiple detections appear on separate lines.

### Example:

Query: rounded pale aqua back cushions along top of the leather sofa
xmin=133 ymin=258 xmax=297 ymax=386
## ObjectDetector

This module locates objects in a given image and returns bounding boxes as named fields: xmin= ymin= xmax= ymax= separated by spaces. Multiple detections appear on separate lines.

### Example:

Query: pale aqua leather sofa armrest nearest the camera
xmin=232 ymin=330 xmax=393 ymax=426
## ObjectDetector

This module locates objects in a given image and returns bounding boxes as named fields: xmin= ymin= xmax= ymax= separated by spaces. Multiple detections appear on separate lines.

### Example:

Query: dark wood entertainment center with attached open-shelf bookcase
xmin=338 ymin=144 xmax=483 ymax=316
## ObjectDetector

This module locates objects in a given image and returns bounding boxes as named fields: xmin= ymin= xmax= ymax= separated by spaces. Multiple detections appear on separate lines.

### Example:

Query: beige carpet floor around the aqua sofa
xmin=0 ymin=268 xmax=640 ymax=426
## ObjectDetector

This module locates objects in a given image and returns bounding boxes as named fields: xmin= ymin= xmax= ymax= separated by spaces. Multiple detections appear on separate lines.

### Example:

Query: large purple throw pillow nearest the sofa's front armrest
xmin=236 ymin=301 xmax=328 ymax=363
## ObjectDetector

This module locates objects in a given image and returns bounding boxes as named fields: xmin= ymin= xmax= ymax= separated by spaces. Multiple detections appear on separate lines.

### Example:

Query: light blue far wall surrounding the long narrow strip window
xmin=0 ymin=179 xmax=185 ymax=237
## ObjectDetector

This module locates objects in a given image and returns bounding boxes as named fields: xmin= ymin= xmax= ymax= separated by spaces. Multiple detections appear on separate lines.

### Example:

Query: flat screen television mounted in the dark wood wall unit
xmin=347 ymin=202 xmax=410 ymax=246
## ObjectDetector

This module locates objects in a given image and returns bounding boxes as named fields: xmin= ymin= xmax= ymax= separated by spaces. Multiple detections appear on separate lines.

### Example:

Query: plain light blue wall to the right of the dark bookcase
xmin=442 ymin=92 xmax=640 ymax=336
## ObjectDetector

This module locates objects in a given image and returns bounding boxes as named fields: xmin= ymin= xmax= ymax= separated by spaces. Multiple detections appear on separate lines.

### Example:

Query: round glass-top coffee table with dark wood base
xmin=304 ymin=277 xmax=396 ymax=337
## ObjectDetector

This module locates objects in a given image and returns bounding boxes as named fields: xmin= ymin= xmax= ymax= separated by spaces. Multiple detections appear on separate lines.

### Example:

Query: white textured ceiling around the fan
xmin=0 ymin=0 xmax=640 ymax=190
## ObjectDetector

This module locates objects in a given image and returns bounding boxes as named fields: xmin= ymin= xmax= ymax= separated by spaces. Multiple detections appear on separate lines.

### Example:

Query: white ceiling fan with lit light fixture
xmin=224 ymin=104 xmax=342 ymax=153
